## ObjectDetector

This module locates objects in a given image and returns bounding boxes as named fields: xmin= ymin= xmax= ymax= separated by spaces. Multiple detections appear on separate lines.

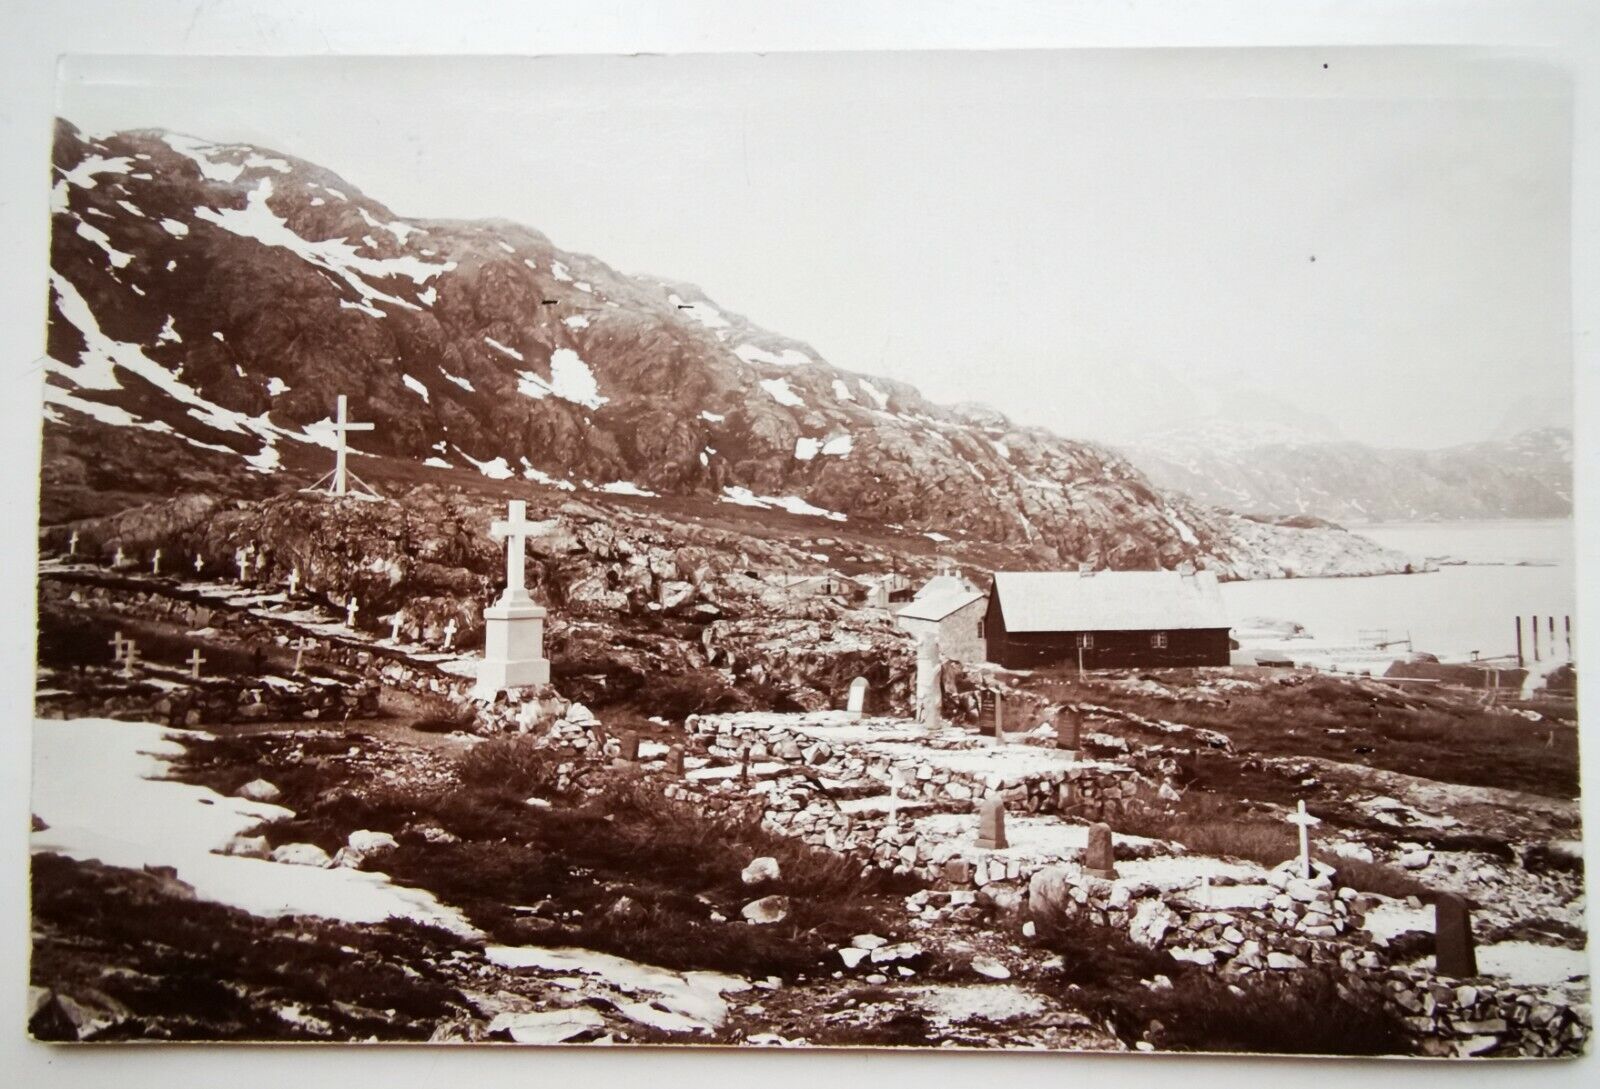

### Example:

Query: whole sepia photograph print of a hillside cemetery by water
xmin=13 ymin=46 xmax=1592 ymax=1063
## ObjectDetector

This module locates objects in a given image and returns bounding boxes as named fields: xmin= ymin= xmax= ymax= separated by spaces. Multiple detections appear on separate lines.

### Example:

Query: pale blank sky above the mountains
xmin=59 ymin=48 xmax=1571 ymax=446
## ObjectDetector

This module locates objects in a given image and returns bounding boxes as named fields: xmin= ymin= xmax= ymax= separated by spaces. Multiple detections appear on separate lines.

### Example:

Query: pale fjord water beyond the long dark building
xmin=1222 ymin=518 xmax=1578 ymax=659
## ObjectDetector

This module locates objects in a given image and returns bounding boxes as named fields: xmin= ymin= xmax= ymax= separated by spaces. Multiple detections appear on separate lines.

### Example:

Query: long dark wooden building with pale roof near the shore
xmin=982 ymin=564 xmax=1230 ymax=670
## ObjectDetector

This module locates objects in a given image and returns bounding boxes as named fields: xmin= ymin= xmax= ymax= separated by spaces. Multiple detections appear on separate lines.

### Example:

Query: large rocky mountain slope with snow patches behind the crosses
xmin=45 ymin=122 xmax=1403 ymax=577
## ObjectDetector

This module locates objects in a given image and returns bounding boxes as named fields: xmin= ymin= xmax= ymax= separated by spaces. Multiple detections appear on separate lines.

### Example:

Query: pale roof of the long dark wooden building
xmin=994 ymin=571 xmax=1229 ymax=632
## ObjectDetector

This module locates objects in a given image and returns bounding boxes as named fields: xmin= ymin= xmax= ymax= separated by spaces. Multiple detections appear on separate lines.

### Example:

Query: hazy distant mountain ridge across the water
xmin=1123 ymin=425 xmax=1573 ymax=523
